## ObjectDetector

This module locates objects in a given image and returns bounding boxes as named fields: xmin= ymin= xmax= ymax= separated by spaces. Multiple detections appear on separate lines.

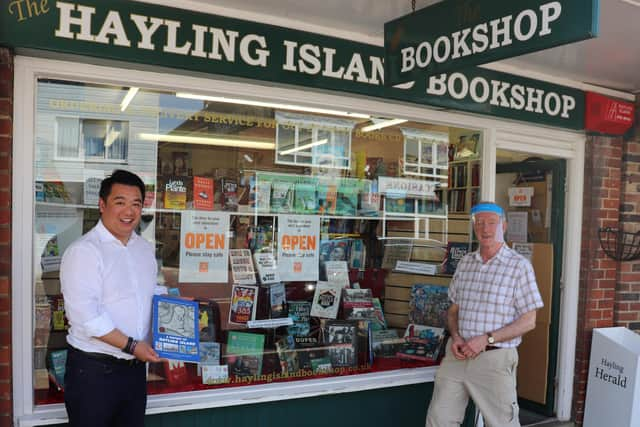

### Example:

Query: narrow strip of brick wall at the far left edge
xmin=0 ymin=48 xmax=13 ymax=426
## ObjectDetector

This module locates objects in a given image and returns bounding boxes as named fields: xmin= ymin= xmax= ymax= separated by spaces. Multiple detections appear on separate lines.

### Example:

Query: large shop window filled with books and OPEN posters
xmin=33 ymin=80 xmax=482 ymax=404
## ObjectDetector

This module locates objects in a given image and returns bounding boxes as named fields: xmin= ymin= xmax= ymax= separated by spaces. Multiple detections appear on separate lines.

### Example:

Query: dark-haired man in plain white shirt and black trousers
xmin=60 ymin=170 xmax=161 ymax=427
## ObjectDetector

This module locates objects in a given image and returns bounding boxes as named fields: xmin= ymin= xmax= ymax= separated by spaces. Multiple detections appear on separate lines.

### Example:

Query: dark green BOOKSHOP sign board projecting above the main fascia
xmin=384 ymin=0 xmax=599 ymax=86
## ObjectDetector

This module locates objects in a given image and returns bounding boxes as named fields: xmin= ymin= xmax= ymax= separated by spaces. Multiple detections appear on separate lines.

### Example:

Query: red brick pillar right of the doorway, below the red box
xmin=573 ymin=136 xmax=624 ymax=423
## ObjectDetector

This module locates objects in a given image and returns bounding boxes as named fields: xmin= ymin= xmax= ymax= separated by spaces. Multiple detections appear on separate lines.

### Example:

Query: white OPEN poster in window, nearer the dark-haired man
xmin=178 ymin=211 xmax=229 ymax=283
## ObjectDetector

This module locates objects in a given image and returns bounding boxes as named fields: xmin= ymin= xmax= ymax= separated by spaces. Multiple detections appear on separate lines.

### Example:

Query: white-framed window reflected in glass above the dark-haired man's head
xmin=56 ymin=117 xmax=129 ymax=162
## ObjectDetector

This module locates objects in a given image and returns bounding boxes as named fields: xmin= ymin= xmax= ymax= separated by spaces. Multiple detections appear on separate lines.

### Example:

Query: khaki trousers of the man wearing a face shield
xmin=426 ymin=341 xmax=520 ymax=427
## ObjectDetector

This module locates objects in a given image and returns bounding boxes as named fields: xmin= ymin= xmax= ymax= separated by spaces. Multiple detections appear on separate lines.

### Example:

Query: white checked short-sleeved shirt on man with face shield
xmin=449 ymin=244 xmax=543 ymax=347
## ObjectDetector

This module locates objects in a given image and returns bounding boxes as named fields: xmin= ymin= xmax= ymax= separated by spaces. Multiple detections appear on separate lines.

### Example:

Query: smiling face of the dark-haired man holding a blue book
xmin=99 ymin=184 xmax=142 ymax=245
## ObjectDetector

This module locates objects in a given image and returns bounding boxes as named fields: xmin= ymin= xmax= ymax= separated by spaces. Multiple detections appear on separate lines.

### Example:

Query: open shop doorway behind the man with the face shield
xmin=495 ymin=149 xmax=566 ymax=425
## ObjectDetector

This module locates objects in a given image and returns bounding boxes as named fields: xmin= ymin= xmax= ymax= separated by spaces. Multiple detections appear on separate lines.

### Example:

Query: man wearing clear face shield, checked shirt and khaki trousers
xmin=426 ymin=202 xmax=543 ymax=427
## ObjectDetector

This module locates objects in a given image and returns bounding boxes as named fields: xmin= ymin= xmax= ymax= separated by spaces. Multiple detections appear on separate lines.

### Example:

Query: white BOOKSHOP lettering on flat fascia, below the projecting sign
xmin=426 ymin=73 xmax=576 ymax=119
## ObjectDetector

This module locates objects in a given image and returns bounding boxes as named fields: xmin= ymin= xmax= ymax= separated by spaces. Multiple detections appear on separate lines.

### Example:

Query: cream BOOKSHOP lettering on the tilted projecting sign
xmin=400 ymin=1 xmax=562 ymax=73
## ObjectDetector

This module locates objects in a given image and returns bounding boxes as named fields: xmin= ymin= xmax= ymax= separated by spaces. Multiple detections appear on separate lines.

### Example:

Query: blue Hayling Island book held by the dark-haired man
xmin=153 ymin=295 xmax=200 ymax=362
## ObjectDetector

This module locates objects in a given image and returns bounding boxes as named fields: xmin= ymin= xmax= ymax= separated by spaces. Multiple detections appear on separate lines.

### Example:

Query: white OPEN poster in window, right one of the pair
xmin=278 ymin=215 xmax=320 ymax=282
